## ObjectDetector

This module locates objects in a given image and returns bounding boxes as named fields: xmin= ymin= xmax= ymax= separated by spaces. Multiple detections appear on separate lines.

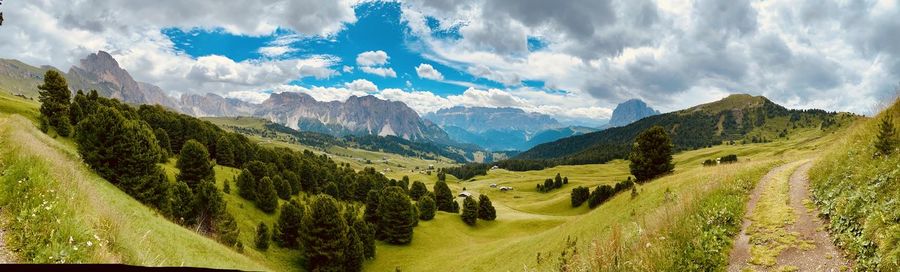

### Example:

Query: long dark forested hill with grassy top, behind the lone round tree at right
xmin=515 ymin=95 xmax=856 ymax=164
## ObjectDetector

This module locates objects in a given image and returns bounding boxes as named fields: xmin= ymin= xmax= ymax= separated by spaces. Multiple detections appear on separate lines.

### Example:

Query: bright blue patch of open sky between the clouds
xmin=162 ymin=2 xmax=512 ymax=96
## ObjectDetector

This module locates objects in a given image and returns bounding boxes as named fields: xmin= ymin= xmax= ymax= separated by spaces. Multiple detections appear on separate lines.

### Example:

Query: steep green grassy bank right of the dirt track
xmin=810 ymin=100 xmax=900 ymax=271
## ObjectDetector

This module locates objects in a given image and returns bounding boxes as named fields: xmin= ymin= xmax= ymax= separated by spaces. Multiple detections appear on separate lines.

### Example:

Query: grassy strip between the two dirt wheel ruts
xmin=747 ymin=161 xmax=814 ymax=267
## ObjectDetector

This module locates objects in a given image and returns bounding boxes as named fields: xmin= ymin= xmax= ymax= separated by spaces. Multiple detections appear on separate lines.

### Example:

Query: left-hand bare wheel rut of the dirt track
xmin=728 ymin=164 xmax=788 ymax=272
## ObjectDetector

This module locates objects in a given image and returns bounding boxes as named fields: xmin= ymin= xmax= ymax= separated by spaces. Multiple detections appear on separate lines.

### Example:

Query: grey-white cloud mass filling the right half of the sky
xmin=403 ymin=0 xmax=900 ymax=114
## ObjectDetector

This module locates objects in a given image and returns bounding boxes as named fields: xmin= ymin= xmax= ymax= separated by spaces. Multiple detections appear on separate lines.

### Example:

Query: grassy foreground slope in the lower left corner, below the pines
xmin=0 ymin=115 xmax=268 ymax=270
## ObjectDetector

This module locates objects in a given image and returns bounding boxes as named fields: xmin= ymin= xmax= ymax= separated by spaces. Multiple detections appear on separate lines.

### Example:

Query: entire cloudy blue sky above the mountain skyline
xmin=0 ymin=0 xmax=900 ymax=125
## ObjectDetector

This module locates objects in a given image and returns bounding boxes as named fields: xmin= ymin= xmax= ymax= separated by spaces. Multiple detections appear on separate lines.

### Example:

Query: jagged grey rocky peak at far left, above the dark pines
xmin=66 ymin=51 xmax=179 ymax=110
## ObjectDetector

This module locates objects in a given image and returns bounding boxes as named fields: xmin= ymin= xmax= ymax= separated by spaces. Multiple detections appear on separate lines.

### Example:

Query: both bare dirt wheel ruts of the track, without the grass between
xmin=728 ymin=162 xmax=850 ymax=272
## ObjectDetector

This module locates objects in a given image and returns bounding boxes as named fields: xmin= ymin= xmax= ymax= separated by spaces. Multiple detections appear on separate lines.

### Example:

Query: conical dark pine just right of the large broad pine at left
xmin=175 ymin=140 xmax=216 ymax=189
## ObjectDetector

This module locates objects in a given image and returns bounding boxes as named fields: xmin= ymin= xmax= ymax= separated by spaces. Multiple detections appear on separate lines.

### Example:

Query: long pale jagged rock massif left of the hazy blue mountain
xmin=253 ymin=92 xmax=448 ymax=142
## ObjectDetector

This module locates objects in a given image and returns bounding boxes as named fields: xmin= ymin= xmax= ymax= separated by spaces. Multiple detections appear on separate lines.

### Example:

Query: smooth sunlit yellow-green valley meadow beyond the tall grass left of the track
xmin=366 ymin=124 xmax=837 ymax=271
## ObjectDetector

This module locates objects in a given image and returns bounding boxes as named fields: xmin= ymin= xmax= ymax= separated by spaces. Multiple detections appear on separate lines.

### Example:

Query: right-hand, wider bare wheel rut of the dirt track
xmin=778 ymin=163 xmax=849 ymax=271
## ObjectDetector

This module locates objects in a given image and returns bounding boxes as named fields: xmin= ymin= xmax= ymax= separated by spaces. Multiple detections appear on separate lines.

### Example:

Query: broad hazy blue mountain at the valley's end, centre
xmin=425 ymin=106 xmax=594 ymax=150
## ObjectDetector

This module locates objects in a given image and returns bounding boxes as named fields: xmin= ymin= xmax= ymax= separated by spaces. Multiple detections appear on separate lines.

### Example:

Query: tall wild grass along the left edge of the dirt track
xmin=536 ymin=161 xmax=776 ymax=271
